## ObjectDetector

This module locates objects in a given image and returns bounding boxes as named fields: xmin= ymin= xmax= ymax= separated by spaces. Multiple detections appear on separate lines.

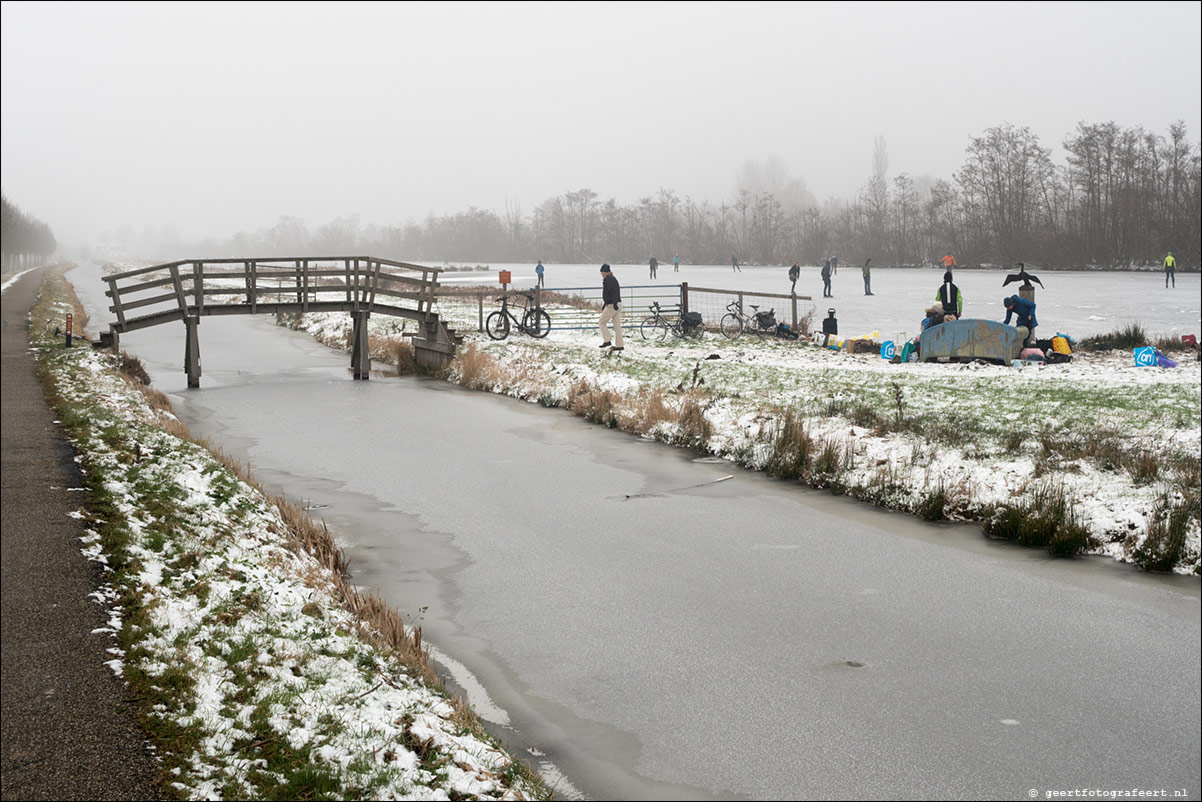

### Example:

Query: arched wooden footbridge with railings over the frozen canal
xmin=105 ymin=256 xmax=458 ymax=387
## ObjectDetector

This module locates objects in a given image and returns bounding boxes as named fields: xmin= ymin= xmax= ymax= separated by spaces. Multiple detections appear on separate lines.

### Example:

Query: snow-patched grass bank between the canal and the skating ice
xmin=283 ymin=298 xmax=1202 ymax=574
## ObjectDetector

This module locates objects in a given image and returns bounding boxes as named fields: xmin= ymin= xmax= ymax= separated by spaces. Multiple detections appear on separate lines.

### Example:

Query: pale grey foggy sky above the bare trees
xmin=0 ymin=2 xmax=1202 ymax=246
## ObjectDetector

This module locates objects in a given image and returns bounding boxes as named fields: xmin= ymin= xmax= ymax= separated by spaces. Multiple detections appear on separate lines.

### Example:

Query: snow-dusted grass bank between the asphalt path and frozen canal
xmin=31 ymin=271 xmax=549 ymax=800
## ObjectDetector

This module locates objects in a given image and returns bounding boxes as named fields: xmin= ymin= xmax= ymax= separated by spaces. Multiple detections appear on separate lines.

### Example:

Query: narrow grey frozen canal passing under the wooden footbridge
xmin=71 ymin=267 xmax=1202 ymax=800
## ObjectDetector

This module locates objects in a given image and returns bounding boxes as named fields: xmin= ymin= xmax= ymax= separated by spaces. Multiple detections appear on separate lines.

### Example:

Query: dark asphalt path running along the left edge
xmin=0 ymin=268 xmax=160 ymax=800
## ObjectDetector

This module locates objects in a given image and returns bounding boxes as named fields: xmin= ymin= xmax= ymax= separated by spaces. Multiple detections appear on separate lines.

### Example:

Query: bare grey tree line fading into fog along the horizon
xmin=105 ymin=123 xmax=1202 ymax=268
